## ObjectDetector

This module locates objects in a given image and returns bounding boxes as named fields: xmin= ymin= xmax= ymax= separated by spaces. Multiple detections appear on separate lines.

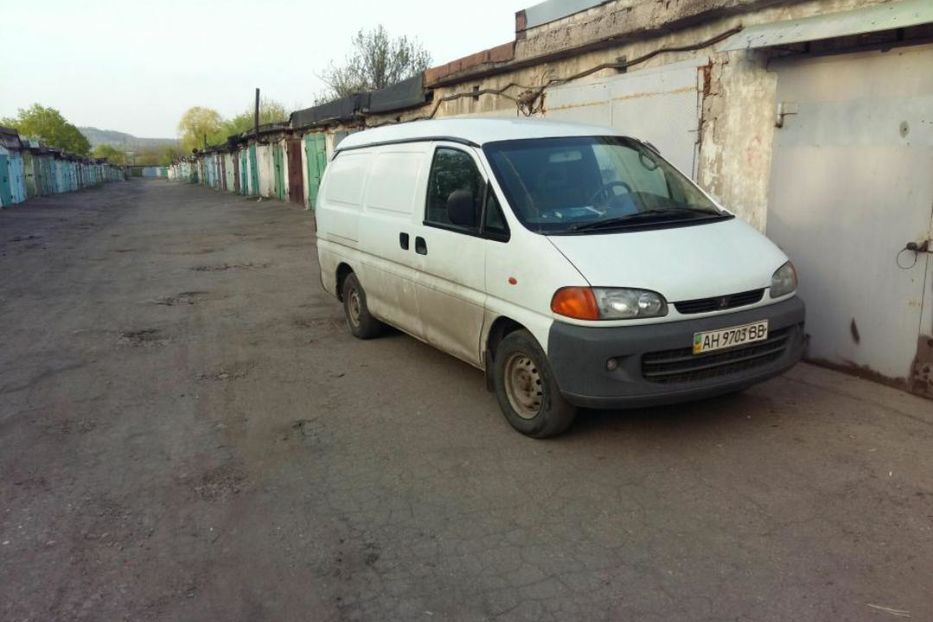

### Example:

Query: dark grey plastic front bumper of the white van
xmin=548 ymin=296 xmax=806 ymax=408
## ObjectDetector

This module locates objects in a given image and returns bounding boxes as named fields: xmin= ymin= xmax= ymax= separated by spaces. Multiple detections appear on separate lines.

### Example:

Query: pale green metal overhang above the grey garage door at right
xmin=718 ymin=0 xmax=933 ymax=52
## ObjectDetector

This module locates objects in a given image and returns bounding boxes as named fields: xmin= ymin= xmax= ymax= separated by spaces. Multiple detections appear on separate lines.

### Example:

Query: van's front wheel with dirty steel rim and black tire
xmin=493 ymin=330 xmax=577 ymax=438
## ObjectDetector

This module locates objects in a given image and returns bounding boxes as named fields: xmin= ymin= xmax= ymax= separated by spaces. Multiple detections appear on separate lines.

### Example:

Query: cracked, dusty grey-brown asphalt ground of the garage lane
xmin=0 ymin=180 xmax=933 ymax=621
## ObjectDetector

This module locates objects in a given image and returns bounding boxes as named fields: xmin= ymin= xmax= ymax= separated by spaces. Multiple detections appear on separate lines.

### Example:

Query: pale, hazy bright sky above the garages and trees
xmin=0 ymin=0 xmax=537 ymax=138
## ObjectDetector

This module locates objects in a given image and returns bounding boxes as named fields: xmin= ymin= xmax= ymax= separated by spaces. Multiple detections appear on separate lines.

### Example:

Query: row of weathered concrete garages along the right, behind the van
xmin=169 ymin=0 xmax=933 ymax=395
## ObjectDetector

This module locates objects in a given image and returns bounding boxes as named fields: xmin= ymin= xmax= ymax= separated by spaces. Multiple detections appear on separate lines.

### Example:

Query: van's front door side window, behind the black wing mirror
xmin=424 ymin=147 xmax=485 ymax=231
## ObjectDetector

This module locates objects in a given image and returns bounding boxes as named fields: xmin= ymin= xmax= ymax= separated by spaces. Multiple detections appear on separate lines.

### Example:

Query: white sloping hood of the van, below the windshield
xmin=548 ymin=218 xmax=787 ymax=302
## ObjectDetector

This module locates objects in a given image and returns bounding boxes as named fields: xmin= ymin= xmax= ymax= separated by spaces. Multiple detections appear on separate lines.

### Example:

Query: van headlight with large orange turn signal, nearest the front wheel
xmin=551 ymin=287 xmax=667 ymax=320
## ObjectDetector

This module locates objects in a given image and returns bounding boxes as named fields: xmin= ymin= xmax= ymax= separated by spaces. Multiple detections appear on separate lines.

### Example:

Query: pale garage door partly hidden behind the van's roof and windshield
xmin=545 ymin=62 xmax=700 ymax=178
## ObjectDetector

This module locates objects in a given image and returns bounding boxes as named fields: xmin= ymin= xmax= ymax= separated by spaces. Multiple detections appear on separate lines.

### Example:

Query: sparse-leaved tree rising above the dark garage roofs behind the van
xmin=318 ymin=25 xmax=431 ymax=100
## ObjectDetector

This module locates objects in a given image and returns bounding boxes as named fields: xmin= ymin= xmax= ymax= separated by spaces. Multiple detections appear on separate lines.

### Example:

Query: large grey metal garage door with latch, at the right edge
xmin=768 ymin=46 xmax=933 ymax=392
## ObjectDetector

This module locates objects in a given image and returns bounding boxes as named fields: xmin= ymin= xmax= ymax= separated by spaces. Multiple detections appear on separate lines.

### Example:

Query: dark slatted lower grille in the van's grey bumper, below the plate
xmin=641 ymin=328 xmax=790 ymax=384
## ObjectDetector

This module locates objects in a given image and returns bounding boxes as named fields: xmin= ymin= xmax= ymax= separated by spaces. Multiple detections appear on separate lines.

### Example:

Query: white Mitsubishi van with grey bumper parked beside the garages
xmin=316 ymin=119 xmax=805 ymax=438
